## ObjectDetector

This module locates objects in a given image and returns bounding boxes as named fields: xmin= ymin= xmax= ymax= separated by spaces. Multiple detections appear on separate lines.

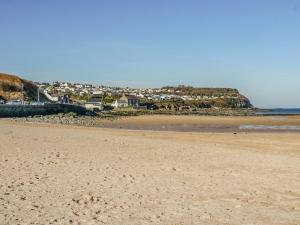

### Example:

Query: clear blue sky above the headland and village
xmin=0 ymin=0 xmax=300 ymax=107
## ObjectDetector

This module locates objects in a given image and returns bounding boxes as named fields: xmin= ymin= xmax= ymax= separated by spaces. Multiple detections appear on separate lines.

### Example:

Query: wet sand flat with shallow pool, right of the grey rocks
xmin=97 ymin=115 xmax=300 ymax=133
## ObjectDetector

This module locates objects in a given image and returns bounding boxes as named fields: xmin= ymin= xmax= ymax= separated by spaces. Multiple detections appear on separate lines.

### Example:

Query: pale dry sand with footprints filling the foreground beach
xmin=0 ymin=118 xmax=300 ymax=225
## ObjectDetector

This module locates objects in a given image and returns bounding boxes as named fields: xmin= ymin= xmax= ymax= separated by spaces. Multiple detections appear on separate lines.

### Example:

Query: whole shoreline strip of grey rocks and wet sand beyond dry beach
xmin=2 ymin=114 xmax=300 ymax=133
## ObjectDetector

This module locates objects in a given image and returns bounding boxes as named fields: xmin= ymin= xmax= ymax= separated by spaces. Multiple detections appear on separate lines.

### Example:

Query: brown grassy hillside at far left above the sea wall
xmin=0 ymin=73 xmax=47 ymax=101
